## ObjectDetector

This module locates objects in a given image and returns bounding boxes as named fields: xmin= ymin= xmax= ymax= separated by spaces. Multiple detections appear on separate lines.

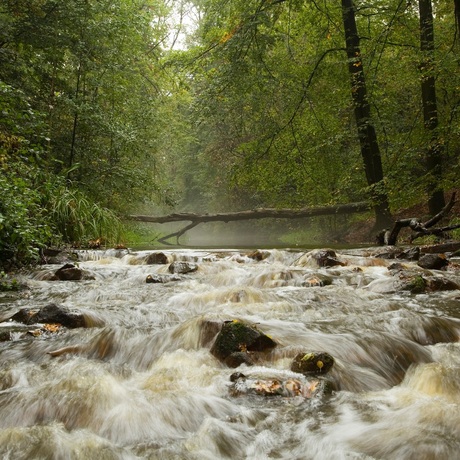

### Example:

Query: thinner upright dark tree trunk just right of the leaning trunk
xmin=418 ymin=0 xmax=446 ymax=215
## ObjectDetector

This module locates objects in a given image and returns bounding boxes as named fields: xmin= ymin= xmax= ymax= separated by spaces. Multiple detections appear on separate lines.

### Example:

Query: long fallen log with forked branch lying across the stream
xmin=129 ymin=201 xmax=371 ymax=244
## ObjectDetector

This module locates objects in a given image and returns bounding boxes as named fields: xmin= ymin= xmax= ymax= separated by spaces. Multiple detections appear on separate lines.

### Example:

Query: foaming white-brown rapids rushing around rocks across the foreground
xmin=0 ymin=250 xmax=460 ymax=460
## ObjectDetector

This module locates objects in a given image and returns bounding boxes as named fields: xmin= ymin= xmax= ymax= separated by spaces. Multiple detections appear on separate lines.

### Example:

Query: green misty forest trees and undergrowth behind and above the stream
xmin=0 ymin=0 xmax=460 ymax=264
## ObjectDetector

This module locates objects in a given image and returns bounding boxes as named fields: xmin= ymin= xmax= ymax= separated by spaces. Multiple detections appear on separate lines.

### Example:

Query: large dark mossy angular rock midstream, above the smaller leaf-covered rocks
xmin=211 ymin=320 xmax=277 ymax=367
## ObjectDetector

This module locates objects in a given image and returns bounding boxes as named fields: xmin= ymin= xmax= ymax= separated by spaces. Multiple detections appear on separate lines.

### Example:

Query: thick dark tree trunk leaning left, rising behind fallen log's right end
xmin=342 ymin=0 xmax=392 ymax=230
